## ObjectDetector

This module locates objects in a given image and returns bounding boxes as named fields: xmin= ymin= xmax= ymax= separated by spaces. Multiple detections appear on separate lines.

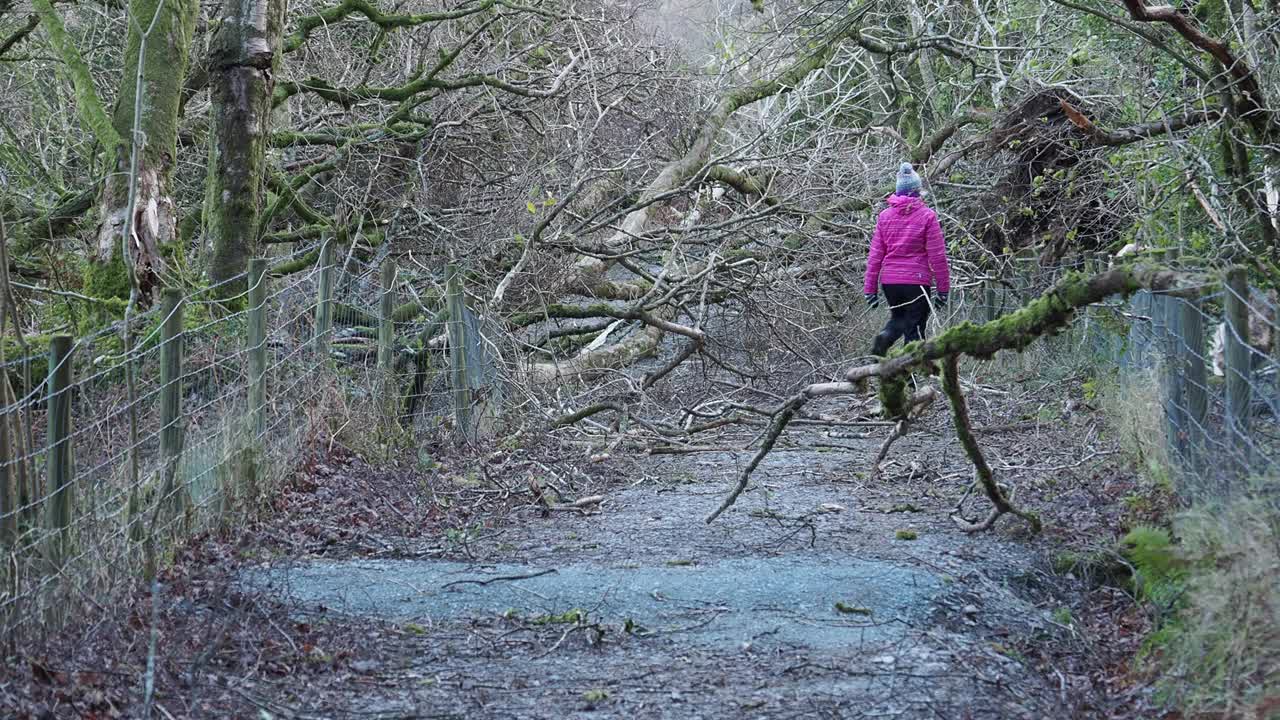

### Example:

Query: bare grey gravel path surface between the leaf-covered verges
xmin=243 ymin=422 xmax=1141 ymax=717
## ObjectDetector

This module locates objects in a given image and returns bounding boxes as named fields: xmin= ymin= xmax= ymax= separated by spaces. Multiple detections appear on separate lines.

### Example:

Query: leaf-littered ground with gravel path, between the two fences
xmin=0 ymin=379 xmax=1172 ymax=719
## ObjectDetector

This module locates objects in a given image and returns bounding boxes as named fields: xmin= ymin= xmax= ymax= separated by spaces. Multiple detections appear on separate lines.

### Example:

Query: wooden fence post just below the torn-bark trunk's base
xmin=160 ymin=287 xmax=191 ymax=515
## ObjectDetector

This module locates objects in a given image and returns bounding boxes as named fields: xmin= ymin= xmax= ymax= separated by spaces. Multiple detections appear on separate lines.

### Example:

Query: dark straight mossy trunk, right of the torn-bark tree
xmin=205 ymin=0 xmax=284 ymax=296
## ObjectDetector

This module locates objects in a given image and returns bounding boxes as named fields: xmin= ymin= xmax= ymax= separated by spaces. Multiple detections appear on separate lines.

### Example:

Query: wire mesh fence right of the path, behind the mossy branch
xmin=946 ymin=261 xmax=1280 ymax=502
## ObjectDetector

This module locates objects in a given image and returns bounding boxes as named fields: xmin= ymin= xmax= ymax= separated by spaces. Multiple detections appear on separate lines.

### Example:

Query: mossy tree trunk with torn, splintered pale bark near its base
xmin=86 ymin=0 xmax=198 ymax=299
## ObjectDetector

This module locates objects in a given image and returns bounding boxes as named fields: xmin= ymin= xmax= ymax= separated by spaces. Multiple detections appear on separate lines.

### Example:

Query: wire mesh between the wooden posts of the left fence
xmin=0 ymin=240 xmax=494 ymax=642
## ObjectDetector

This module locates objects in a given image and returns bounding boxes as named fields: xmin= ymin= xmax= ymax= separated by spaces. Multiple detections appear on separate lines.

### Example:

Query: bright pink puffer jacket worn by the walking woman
xmin=863 ymin=195 xmax=951 ymax=295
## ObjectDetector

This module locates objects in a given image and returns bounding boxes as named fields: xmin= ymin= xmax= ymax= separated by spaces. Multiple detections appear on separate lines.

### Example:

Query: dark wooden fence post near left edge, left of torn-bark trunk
xmin=46 ymin=334 xmax=73 ymax=565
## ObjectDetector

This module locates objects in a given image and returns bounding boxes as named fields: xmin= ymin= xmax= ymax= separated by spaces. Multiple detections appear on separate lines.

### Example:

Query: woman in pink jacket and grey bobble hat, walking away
xmin=863 ymin=163 xmax=951 ymax=357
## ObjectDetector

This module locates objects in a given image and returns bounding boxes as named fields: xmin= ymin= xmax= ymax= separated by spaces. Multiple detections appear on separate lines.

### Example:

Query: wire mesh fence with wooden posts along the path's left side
xmin=0 ymin=243 xmax=500 ymax=642
